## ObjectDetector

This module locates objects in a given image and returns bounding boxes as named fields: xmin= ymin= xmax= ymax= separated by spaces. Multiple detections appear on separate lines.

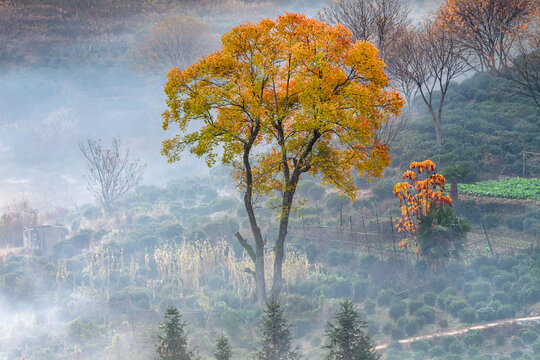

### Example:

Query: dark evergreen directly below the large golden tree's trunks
xmin=256 ymin=298 xmax=300 ymax=360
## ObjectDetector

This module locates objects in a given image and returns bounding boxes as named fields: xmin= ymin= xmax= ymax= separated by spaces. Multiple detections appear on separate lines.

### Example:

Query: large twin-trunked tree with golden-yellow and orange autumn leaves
xmin=162 ymin=14 xmax=403 ymax=305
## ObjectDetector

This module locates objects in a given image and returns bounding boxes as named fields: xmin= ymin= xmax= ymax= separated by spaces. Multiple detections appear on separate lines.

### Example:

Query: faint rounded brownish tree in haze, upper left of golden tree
xmin=132 ymin=15 xmax=210 ymax=76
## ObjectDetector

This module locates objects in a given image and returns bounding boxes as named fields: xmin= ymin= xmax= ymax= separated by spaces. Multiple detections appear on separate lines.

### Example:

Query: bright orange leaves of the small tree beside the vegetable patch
xmin=394 ymin=160 xmax=452 ymax=251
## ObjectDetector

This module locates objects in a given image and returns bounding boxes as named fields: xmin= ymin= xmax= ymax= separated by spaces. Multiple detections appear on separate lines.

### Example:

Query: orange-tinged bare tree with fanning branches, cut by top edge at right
xmin=439 ymin=0 xmax=538 ymax=71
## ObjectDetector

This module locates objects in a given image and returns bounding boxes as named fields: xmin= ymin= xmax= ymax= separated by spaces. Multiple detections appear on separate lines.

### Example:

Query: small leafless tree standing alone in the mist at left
xmin=79 ymin=138 xmax=146 ymax=211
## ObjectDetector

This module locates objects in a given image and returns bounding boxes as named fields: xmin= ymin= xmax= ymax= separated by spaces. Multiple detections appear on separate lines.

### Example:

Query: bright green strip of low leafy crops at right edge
xmin=458 ymin=177 xmax=540 ymax=201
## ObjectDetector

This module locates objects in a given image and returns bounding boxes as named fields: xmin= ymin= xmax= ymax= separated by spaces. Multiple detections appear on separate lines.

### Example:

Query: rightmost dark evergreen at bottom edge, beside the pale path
xmin=325 ymin=300 xmax=381 ymax=360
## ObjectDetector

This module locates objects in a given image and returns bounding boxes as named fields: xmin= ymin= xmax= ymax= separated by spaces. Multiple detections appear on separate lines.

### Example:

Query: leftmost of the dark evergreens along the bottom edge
xmin=157 ymin=306 xmax=194 ymax=360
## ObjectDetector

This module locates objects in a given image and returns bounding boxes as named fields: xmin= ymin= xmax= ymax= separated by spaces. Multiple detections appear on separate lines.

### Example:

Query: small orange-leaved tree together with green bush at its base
xmin=394 ymin=160 xmax=470 ymax=261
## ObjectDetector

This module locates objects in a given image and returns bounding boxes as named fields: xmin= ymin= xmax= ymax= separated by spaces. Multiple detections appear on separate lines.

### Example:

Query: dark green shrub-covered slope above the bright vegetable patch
xmin=393 ymin=73 xmax=540 ymax=180
